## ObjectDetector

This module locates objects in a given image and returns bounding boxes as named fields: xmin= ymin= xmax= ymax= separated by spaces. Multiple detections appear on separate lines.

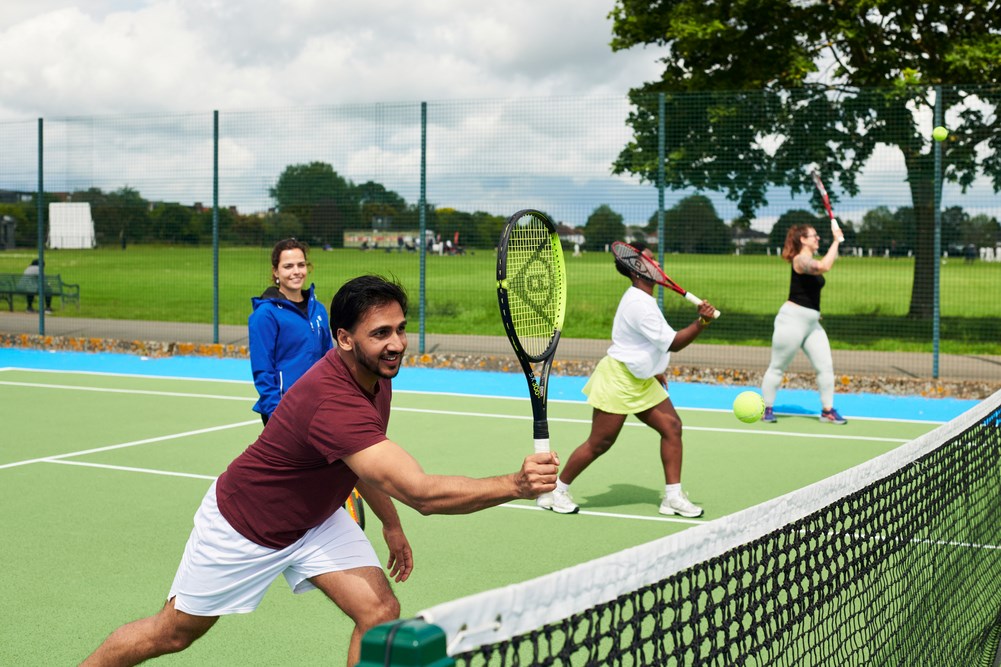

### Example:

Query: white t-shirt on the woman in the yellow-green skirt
xmin=608 ymin=285 xmax=677 ymax=380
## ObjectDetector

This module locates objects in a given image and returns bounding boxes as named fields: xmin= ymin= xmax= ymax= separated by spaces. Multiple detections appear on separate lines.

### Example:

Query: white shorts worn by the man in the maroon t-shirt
xmin=167 ymin=482 xmax=381 ymax=616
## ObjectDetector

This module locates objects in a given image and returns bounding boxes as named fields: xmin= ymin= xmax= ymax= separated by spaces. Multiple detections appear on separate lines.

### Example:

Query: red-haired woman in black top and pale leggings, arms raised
xmin=761 ymin=220 xmax=847 ymax=424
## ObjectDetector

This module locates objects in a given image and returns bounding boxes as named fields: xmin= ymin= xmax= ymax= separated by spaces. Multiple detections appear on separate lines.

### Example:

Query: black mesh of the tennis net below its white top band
xmin=454 ymin=395 xmax=1001 ymax=667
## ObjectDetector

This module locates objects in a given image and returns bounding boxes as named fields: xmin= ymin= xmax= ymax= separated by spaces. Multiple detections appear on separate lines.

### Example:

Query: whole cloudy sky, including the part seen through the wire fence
xmin=0 ymin=0 xmax=984 ymax=230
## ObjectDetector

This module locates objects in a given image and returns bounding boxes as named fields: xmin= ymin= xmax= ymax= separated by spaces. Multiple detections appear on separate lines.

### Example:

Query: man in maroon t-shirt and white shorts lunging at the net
xmin=83 ymin=275 xmax=559 ymax=665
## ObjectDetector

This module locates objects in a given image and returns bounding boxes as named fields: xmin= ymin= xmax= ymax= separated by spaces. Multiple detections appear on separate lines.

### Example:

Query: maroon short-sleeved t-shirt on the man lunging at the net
xmin=215 ymin=348 xmax=392 ymax=549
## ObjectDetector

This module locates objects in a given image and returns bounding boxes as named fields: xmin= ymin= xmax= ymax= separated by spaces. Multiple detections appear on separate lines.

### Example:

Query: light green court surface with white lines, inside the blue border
xmin=0 ymin=370 xmax=935 ymax=665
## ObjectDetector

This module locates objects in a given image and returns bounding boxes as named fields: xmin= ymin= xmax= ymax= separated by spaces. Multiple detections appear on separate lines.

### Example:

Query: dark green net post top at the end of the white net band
xmin=357 ymin=619 xmax=455 ymax=667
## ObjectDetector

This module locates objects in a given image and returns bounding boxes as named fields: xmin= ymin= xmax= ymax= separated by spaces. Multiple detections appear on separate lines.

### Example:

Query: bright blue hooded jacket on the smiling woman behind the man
xmin=248 ymin=284 xmax=333 ymax=417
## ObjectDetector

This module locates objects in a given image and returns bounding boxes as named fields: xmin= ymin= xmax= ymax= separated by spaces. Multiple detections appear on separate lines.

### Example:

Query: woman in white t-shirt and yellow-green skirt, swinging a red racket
xmin=551 ymin=243 xmax=716 ymax=517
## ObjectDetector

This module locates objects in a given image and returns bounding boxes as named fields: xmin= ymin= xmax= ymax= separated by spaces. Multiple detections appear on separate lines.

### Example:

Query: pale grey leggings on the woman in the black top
xmin=761 ymin=301 xmax=834 ymax=410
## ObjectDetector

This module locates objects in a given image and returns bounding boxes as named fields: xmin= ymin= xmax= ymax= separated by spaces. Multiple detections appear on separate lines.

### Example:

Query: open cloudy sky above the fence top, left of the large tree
xmin=0 ymin=0 xmax=659 ymax=118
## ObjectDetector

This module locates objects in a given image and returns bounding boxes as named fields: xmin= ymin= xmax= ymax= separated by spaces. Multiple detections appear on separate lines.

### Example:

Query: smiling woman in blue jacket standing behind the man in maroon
xmin=249 ymin=238 xmax=333 ymax=424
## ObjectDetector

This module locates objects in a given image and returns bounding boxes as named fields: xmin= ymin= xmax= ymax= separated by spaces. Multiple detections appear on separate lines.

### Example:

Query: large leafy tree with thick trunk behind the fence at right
xmin=611 ymin=0 xmax=1001 ymax=317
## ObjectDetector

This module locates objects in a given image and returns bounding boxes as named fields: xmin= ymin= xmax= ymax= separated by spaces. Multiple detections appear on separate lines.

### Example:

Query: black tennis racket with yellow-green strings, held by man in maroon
xmin=497 ymin=209 xmax=567 ymax=509
